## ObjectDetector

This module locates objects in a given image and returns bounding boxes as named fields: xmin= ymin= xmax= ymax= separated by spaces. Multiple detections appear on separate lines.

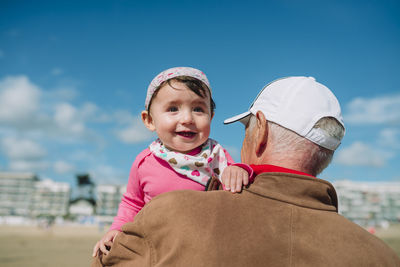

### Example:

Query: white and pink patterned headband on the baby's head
xmin=144 ymin=67 xmax=211 ymax=109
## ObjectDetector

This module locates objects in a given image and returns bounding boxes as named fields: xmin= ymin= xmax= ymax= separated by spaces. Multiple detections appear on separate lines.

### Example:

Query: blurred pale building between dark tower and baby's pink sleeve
xmin=95 ymin=184 xmax=126 ymax=223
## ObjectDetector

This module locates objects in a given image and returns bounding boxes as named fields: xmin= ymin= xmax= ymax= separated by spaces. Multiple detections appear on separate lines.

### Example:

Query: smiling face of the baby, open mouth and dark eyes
xmin=145 ymin=81 xmax=212 ymax=153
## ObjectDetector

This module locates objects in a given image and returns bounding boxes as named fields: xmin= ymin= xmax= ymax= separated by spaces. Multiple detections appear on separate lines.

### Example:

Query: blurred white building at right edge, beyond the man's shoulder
xmin=333 ymin=181 xmax=400 ymax=226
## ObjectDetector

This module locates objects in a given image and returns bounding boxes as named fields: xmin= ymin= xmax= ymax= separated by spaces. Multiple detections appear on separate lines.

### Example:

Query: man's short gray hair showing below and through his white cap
xmin=248 ymin=115 xmax=344 ymax=176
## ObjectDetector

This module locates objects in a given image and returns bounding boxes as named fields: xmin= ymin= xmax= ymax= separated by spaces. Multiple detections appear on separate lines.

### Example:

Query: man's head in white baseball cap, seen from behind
xmin=224 ymin=77 xmax=345 ymax=175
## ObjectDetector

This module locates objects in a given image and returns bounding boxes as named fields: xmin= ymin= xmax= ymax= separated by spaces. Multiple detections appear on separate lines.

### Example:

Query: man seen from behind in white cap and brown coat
xmin=93 ymin=77 xmax=400 ymax=267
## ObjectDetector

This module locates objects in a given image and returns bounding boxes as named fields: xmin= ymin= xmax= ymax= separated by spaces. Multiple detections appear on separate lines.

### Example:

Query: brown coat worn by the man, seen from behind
xmin=92 ymin=173 xmax=400 ymax=267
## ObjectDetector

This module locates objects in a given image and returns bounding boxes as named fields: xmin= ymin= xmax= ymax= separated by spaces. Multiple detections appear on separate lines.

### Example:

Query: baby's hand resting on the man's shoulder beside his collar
xmin=221 ymin=166 xmax=249 ymax=193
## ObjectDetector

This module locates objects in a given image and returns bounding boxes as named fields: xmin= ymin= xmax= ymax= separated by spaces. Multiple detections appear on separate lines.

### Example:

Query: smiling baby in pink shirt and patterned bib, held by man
xmin=92 ymin=67 xmax=252 ymax=257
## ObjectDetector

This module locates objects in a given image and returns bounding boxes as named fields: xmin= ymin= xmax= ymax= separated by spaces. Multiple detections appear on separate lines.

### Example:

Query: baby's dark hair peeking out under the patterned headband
xmin=147 ymin=76 xmax=215 ymax=114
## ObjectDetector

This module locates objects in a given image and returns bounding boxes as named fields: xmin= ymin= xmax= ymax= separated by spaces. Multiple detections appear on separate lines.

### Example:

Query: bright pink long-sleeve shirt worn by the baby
xmin=110 ymin=147 xmax=238 ymax=230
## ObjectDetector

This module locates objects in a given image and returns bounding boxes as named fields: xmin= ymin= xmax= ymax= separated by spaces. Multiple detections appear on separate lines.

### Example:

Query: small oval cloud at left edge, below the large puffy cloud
xmin=1 ymin=137 xmax=47 ymax=160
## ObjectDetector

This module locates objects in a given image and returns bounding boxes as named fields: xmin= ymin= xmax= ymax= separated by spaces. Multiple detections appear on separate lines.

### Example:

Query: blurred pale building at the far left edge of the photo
xmin=0 ymin=172 xmax=38 ymax=217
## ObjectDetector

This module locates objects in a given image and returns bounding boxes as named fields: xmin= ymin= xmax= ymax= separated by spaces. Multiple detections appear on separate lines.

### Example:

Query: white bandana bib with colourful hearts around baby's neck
xmin=149 ymin=138 xmax=228 ymax=185
